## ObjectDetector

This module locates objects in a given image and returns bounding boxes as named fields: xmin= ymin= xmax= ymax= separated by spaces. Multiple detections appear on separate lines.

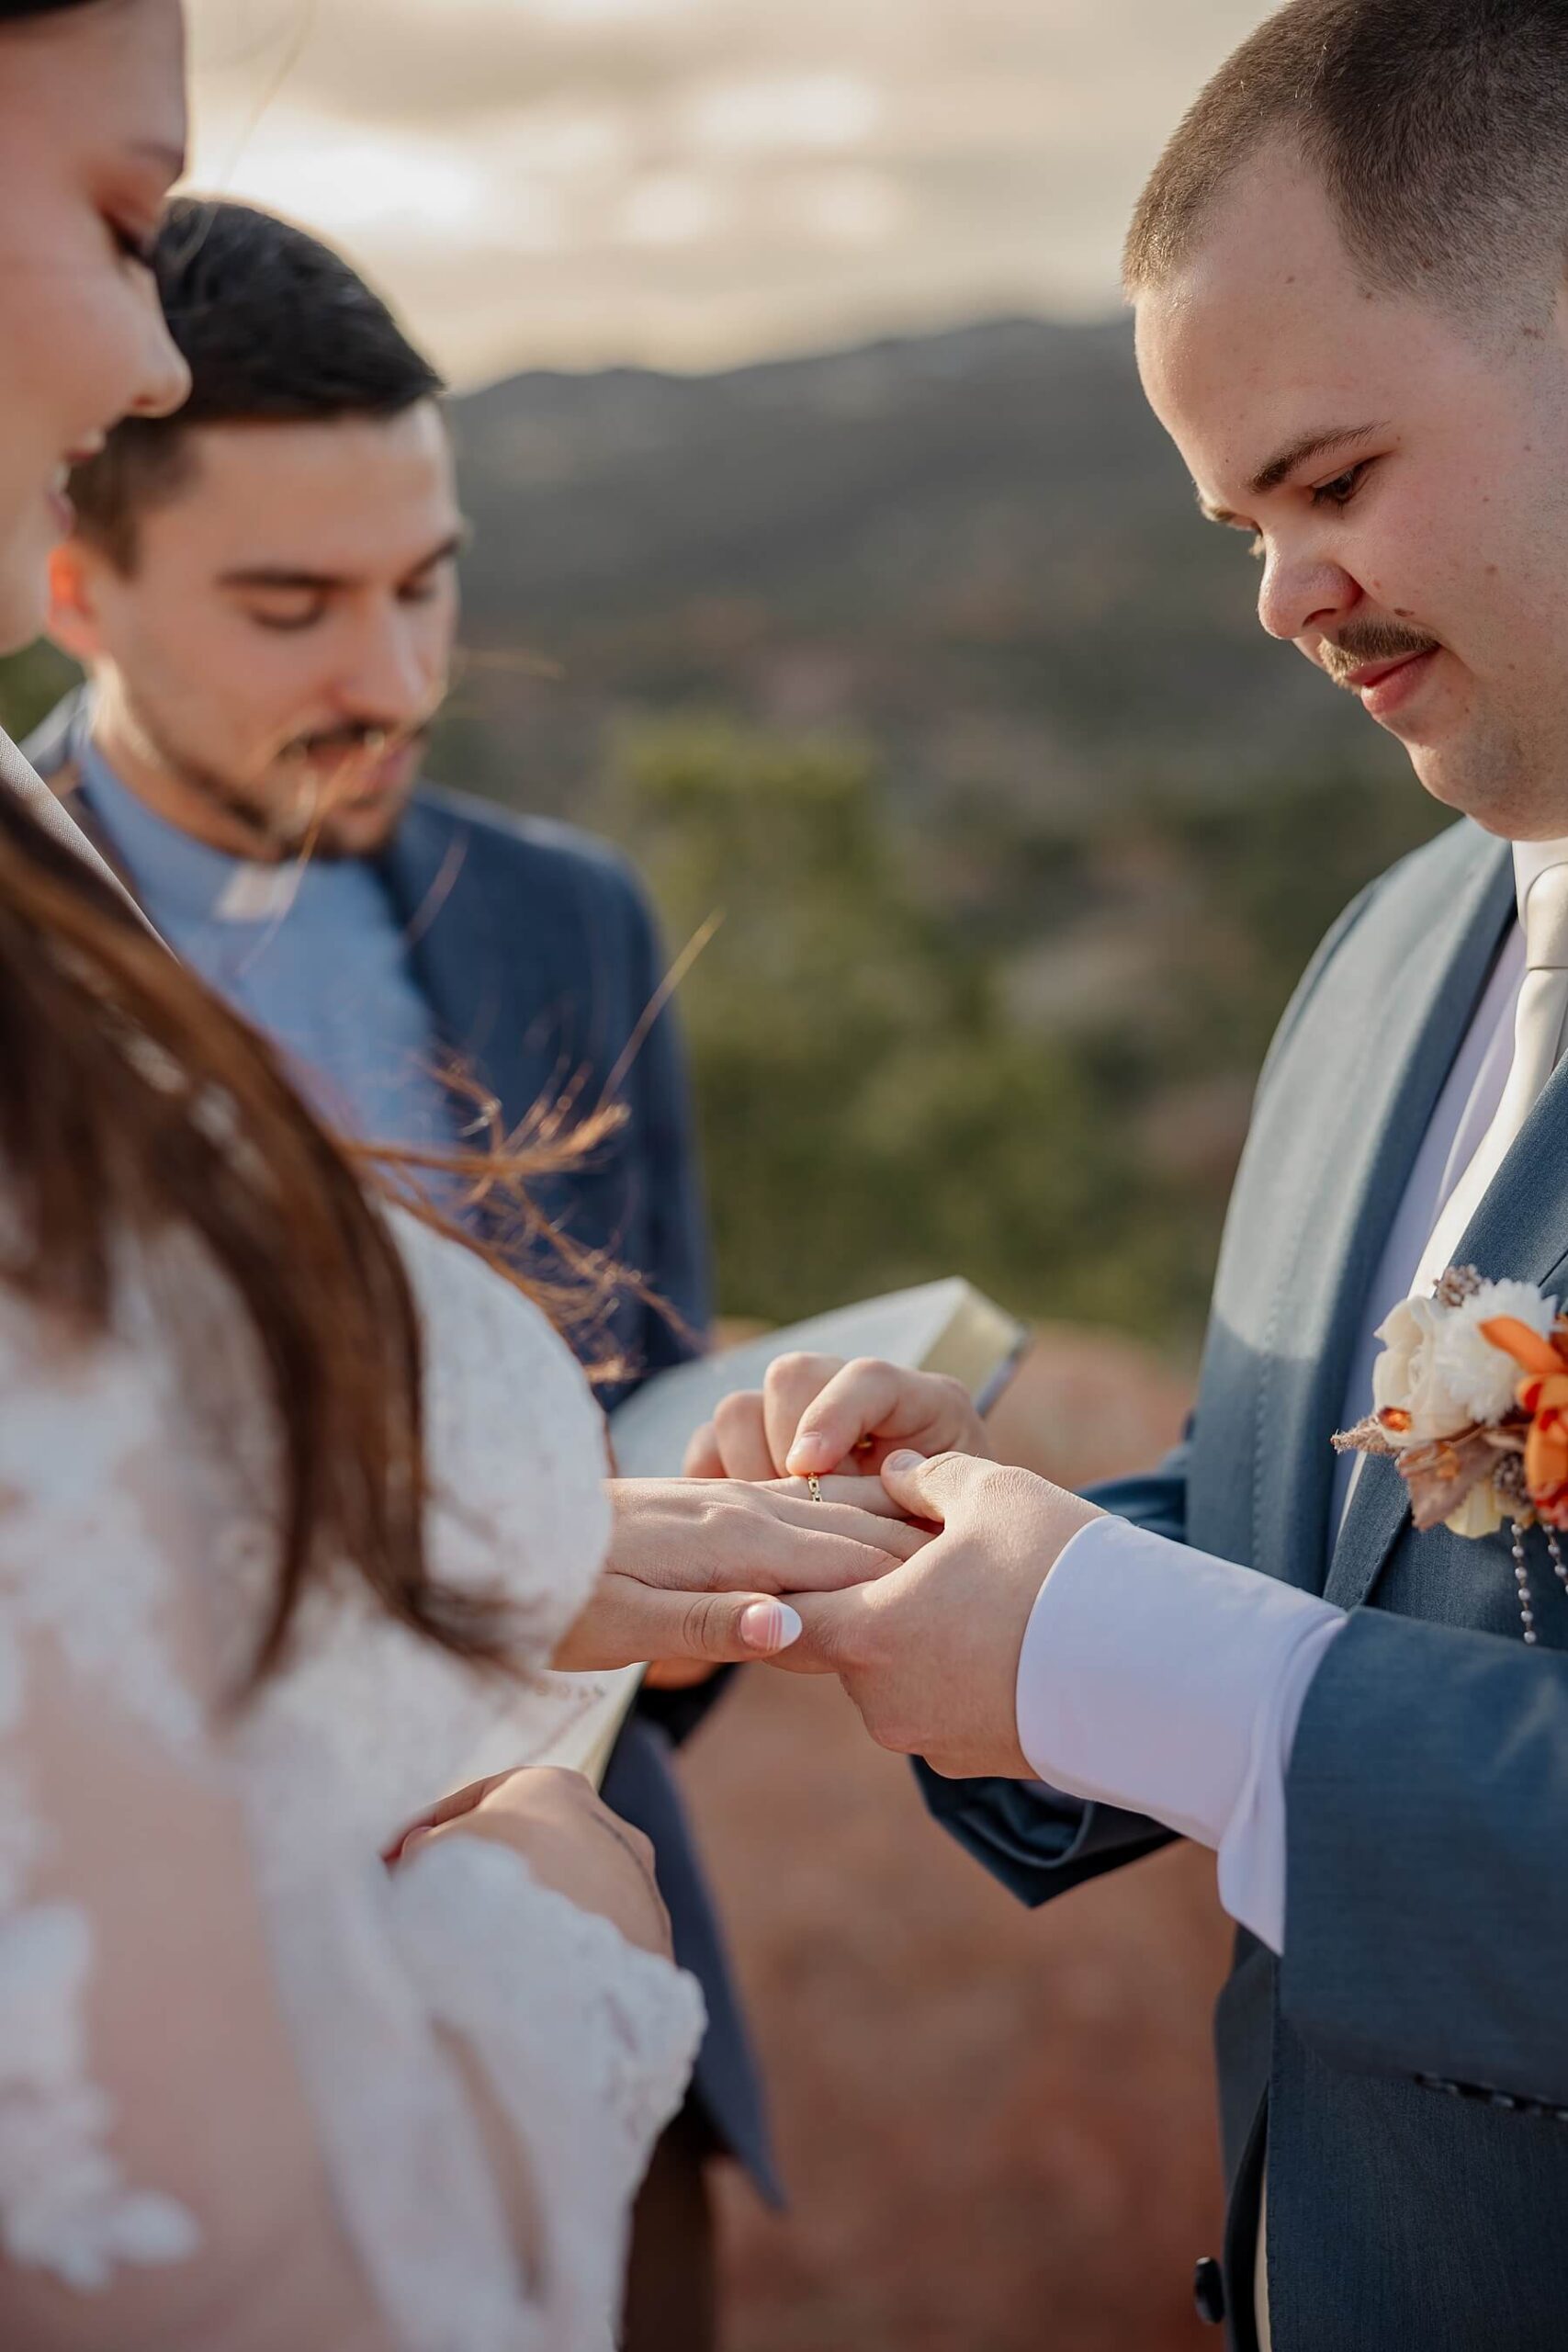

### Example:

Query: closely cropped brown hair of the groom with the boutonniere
xmin=1123 ymin=0 xmax=1568 ymax=320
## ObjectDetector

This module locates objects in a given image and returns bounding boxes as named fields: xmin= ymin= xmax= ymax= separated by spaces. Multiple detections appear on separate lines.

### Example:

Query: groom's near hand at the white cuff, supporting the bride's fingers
xmin=781 ymin=1453 xmax=1102 ymax=1781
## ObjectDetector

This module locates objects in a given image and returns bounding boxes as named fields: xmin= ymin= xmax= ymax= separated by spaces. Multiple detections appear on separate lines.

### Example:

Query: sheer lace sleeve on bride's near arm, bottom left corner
xmin=0 ymin=1486 xmax=395 ymax=2352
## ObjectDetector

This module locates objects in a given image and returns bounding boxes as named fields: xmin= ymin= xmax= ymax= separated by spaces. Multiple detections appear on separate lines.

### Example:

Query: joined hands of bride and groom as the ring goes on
xmin=559 ymin=1355 xmax=1100 ymax=1778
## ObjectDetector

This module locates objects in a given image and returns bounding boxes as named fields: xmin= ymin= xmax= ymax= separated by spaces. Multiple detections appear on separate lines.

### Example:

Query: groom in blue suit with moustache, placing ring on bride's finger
xmin=703 ymin=0 xmax=1568 ymax=2352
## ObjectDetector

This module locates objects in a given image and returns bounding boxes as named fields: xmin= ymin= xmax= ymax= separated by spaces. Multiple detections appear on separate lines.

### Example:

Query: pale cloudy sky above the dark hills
xmin=193 ymin=0 xmax=1265 ymax=383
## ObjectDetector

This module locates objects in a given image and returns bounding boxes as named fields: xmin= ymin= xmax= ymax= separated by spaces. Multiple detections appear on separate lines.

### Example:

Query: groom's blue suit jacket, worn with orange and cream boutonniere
xmin=924 ymin=823 xmax=1568 ymax=2352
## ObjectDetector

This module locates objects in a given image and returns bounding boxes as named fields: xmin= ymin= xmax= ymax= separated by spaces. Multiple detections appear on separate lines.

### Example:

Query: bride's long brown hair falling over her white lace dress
xmin=0 ymin=788 xmax=616 ymax=1687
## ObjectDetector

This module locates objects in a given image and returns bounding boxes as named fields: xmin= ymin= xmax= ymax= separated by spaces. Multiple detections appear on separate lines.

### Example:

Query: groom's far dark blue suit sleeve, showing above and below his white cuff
xmin=915 ymin=1432 xmax=1192 ymax=1907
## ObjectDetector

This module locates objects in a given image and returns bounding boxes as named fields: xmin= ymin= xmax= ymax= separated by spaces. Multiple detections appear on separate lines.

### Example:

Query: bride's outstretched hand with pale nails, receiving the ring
xmin=552 ymin=1477 xmax=926 ymax=1672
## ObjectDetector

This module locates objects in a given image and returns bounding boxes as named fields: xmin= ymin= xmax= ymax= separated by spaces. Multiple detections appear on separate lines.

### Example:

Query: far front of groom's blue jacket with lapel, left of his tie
xmin=1187 ymin=826 xmax=1512 ymax=1592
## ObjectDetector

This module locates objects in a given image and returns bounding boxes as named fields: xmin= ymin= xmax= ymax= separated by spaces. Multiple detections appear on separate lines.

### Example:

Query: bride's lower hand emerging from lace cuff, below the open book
xmin=395 ymin=1764 xmax=670 ymax=1959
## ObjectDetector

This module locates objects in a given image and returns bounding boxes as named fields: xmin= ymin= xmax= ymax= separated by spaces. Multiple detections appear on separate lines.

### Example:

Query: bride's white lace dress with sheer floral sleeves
xmin=0 ymin=1221 xmax=701 ymax=2352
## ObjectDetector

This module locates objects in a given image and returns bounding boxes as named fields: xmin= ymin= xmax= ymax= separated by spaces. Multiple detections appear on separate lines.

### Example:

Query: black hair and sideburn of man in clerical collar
xmin=71 ymin=198 xmax=446 ymax=571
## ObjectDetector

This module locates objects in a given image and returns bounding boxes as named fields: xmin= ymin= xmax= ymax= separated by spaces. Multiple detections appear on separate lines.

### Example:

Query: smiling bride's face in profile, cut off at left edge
xmin=0 ymin=0 xmax=190 ymax=650
